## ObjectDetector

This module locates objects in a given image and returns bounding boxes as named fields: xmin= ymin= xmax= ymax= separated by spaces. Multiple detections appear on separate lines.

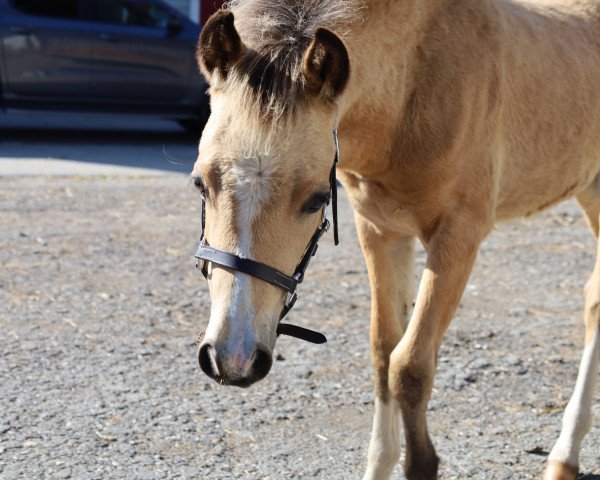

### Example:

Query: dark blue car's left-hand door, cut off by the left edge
xmin=0 ymin=0 xmax=95 ymax=101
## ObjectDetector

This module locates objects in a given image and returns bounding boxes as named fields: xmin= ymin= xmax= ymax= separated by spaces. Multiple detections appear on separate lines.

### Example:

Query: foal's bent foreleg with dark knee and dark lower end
xmin=389 ymin=216 xmax=487 ymax=480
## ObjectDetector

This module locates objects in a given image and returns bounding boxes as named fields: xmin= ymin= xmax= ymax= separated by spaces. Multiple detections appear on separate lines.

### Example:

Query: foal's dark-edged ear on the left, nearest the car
xmin=196 ymin=10 xmax=245 ymax=81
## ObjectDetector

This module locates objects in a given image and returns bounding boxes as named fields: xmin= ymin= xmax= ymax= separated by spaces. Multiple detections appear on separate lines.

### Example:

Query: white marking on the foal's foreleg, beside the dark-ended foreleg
xmin=363 ymin=398 xmax=400 ymax=480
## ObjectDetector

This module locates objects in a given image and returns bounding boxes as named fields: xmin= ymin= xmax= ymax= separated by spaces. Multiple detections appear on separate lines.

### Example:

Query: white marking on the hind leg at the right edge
xmin=548 ymin=332 xmax=600 ymax=467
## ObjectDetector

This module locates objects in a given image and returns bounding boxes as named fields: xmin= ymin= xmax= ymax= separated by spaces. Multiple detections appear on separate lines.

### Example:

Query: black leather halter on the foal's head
xmin=196 ymin=129 xmax=340 ymax=343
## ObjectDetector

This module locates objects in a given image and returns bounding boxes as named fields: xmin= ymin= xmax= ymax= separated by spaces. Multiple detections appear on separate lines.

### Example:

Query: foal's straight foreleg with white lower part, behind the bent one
xmin=356 ymin=214 xmax=415 ymax=480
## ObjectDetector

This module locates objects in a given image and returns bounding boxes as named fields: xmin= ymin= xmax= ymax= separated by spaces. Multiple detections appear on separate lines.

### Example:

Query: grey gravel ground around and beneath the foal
xmin=0 ymin=174 xmax=600 ymax=480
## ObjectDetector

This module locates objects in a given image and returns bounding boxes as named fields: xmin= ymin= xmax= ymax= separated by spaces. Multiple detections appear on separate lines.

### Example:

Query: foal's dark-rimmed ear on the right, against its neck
xmin=302 ymin=27 xmax=350 ymax=100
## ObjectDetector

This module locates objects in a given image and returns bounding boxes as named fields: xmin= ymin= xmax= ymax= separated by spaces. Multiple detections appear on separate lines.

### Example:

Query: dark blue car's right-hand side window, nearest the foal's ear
xmin=93 ymin=0 xmax=170 ymax=28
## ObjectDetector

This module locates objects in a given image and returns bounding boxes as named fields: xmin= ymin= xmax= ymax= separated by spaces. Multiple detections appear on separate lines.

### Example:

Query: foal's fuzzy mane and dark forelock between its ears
xmin=226 ymin=0 xmax=362 ymax=118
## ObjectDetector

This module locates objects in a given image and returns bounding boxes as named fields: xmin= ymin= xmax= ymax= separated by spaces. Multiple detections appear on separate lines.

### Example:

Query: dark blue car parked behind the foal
xmin=0 ymin=0 xmax=208 ymax=129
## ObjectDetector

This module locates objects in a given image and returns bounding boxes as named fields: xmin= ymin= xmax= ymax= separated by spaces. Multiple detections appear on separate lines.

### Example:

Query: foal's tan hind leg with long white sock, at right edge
xmin=544 ymin=181 xmax=600 ymax=480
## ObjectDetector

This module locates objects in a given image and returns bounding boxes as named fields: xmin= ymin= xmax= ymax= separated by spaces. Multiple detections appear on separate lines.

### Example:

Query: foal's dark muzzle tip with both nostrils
xmin=198 ymin=341 xmax=273 ymax=387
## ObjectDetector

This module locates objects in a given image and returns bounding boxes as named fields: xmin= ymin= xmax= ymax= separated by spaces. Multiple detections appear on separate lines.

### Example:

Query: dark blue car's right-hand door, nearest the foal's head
xmin=91 ymin=0 xmax=195 ymax=105
